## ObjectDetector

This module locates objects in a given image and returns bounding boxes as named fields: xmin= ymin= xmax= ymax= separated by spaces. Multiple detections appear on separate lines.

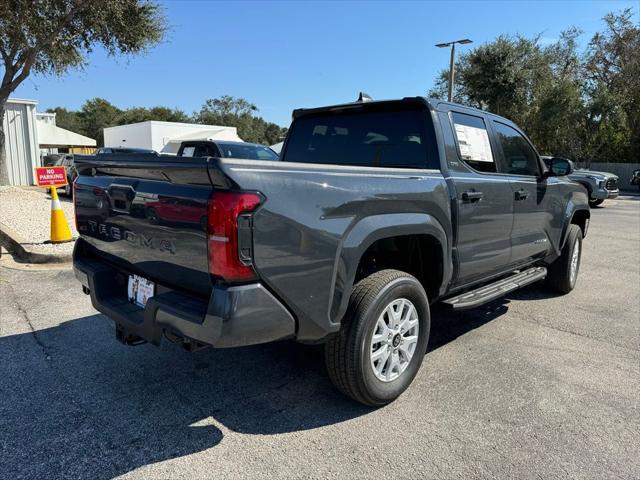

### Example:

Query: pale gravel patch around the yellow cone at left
xmin=0 ymin=186 xmax=78 ymax=255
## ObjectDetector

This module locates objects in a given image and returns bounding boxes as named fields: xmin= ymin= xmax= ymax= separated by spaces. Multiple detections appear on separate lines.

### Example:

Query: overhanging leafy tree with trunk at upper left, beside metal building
xmin=0 ymin=0 xmax=167 ymax=184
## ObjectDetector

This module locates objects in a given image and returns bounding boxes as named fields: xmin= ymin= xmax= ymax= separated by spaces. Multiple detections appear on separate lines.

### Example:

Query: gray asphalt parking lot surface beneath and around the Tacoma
xmin=0 ymin=197 xmax=640 ymax=479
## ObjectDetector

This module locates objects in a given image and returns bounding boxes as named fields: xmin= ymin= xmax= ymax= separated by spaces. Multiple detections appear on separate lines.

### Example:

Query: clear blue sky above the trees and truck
xmin=13 ymin=0 xmax=638 ymax=126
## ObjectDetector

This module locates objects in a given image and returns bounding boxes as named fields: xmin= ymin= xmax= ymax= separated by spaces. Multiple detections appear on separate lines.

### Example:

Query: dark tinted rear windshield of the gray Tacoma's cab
xmin=282 ymin=110 xmax=432 ymax=168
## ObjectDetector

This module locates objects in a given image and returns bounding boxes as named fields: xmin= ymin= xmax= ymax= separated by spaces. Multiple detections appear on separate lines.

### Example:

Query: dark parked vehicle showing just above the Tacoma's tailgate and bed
xmin=178 ymin=140 xmax=279 ymax=161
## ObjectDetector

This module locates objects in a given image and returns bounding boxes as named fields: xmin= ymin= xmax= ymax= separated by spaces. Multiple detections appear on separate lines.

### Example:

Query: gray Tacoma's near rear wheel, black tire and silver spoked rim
xmin=325 ymin=270 xmax=431 ymax=406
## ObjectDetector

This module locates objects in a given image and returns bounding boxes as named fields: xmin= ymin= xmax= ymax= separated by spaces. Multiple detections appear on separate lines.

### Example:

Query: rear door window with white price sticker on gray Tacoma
xmin=451 ymin=112 xmax=497 ymax=172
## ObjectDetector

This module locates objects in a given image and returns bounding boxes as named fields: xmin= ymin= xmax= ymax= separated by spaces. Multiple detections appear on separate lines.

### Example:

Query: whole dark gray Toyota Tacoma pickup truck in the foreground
xmin=74 ymin=97 xmax=590 ymax=406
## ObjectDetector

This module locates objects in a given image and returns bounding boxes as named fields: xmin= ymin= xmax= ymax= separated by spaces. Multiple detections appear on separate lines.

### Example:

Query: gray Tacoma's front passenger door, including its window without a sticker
xmin=492 ymin=120 xmax=562 ymax=265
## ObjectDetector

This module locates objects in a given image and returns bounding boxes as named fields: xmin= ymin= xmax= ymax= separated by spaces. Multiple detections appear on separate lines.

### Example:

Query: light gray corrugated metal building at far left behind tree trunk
xmin=3 ymin=98 xmax=40 ymax=185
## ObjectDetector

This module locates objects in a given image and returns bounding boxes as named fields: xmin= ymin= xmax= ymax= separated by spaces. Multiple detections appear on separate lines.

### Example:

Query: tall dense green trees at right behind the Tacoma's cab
xmin=429 ymin=10 xmax=640 ymax=162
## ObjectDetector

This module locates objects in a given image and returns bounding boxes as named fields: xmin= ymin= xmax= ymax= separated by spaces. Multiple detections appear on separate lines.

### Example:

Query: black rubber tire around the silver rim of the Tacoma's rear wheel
xmin=324 ymin=270 xmax=431 ymax=407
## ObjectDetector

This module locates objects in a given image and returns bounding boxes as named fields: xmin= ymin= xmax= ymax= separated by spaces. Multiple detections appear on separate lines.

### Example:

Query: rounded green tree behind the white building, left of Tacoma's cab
xmin=194 ymin=95 xmax=287 ymax=145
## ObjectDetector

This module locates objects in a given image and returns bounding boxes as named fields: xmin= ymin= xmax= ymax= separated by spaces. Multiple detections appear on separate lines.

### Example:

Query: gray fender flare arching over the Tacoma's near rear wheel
xmin=329 ymin=213 xmax=452 ymax=325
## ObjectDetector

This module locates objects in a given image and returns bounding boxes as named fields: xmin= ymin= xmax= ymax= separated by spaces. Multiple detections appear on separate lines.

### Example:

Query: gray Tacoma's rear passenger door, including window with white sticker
xmin=440 ymin=110 xmax=513 ymax=285
